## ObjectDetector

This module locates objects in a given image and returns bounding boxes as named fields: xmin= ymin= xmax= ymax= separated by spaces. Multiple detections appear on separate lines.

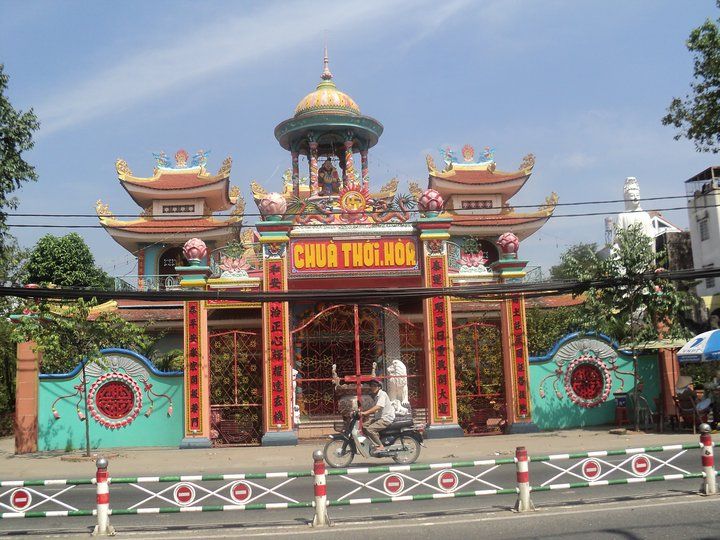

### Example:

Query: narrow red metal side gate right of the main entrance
xmin=453 ymin=321 xmax=507 ymax=435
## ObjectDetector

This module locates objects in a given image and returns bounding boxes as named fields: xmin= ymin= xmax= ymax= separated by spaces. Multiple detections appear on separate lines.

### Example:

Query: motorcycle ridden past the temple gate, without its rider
xmin=324 ymin=411 xmax=424 ymax=468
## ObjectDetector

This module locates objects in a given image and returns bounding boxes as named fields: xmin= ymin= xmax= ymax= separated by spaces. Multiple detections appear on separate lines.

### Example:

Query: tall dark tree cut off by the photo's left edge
xmin=0 ymin=64 xmax=40 ymax=251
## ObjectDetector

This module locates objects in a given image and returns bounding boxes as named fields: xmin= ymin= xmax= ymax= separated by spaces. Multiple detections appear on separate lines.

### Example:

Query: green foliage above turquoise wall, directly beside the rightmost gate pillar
xmin=525 ymin=306 xmax=580 ymax=356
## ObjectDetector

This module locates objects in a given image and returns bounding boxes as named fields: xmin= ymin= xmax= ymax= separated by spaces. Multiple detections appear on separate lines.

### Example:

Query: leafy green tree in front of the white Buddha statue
xmin=573 ymin=225 xmax=696 ymax=346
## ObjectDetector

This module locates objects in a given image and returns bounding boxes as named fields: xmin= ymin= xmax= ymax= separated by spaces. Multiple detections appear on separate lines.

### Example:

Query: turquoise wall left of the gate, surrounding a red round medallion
xmin=38 ymin=349 xmax=184 ymax=451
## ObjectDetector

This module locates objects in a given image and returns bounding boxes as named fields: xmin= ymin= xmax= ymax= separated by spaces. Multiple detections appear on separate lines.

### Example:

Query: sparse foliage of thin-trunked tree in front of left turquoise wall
xmin=13 ymin=299 xmax=151 ymax=373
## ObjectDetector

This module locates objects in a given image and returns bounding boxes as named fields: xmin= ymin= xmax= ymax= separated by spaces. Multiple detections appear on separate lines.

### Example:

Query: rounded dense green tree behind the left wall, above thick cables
xmin=26 ymin=233 xmax=112 ymax=288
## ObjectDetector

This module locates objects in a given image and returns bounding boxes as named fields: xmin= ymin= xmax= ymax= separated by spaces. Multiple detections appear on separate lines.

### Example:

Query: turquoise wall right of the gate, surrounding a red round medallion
xmin=530 ymin=333 xmax=660 ymax=430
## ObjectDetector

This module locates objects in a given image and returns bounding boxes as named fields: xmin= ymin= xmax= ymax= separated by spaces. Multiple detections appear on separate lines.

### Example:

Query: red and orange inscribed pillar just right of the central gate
xmin=417 ymin=218 xmax=463 ymax=439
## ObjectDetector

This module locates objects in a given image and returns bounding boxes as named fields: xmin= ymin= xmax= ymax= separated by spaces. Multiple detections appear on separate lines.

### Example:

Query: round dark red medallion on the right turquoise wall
xmin=565 ymin=355 xmax=612 ymax=409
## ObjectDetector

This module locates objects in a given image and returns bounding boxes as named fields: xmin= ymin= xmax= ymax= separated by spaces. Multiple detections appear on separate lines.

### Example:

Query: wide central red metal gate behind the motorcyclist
xmin=292 ymin=304 xmax=425 ymax=427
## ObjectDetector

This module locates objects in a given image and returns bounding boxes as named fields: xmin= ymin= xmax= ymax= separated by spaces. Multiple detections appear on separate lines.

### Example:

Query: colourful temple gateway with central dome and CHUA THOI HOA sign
xmin=53 ymin=51 xmax=557 ymax=447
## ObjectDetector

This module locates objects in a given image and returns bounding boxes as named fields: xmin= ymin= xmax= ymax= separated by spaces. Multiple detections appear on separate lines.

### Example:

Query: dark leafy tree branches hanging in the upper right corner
xmin=662 ymin=0 xmax=720 ymax=153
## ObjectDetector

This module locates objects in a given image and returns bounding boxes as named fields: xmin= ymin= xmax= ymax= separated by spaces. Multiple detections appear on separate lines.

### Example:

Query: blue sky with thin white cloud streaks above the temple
xmin=0 ymin=0 xmax=720 ymax=274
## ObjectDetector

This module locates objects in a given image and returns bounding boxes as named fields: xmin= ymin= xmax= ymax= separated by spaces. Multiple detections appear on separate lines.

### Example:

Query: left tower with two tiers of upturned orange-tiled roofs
xmin=96 ymin=150 xmax=245 ymax=289
